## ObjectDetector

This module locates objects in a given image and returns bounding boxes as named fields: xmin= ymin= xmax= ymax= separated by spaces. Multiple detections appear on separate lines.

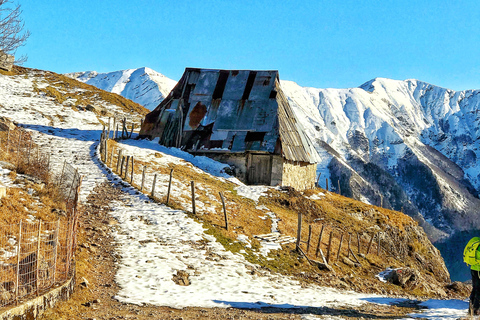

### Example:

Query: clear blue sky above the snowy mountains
xmin=17 ymin=0 xmax=480 ymax=90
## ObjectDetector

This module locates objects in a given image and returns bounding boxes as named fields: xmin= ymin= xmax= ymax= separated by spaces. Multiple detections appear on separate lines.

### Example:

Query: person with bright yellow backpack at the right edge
xmin=463 ymin=237 xmax=480 ymax=315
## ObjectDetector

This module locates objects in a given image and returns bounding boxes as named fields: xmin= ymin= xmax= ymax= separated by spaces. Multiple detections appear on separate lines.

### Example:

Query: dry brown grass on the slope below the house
xmin=99 ymin=140 xmax=456 ymax=295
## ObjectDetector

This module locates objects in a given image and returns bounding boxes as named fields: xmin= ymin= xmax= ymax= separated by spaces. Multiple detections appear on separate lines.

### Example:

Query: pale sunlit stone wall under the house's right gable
xmin=282 ymin=159 xmax=317 ymax=190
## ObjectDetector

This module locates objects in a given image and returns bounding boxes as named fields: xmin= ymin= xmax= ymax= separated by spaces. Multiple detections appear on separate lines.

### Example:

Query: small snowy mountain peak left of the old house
xmin=66 ymin=67 xmax=177 ymax=110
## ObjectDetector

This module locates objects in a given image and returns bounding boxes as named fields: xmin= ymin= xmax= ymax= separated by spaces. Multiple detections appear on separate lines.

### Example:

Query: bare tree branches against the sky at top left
xmin=0 ymin=0 xmax=30 ymax=62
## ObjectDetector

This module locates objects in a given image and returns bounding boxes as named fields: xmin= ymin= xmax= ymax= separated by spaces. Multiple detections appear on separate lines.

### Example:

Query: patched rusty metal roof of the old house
xmin=141 ymin=68 xmax=318 ymax=163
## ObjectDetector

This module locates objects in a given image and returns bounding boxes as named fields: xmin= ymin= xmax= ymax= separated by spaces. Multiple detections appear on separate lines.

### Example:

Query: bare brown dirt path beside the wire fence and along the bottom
xmin=35 ymin=183 xmax=412 ymax=319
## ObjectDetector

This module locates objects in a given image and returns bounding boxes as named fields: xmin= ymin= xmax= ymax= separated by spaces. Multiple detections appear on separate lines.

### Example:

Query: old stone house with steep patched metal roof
xmin=140 ymin=68 xmax=318 ymax=190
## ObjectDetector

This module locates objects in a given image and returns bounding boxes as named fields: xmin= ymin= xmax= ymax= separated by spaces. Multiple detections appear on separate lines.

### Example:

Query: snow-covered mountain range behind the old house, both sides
xmin=65 ymin=68 xmax=480 ymax=279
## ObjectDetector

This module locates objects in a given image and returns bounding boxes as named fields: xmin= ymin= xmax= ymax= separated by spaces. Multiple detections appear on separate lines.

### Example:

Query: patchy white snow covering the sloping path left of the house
xmin=0 ymin=71 xmax=468 ymax=319
